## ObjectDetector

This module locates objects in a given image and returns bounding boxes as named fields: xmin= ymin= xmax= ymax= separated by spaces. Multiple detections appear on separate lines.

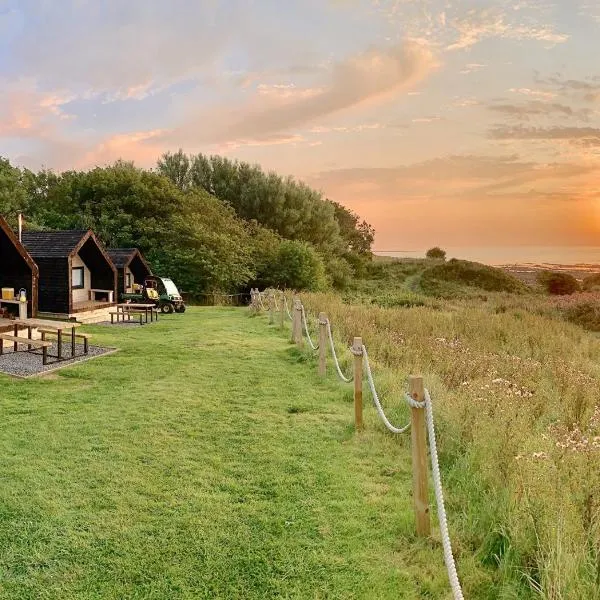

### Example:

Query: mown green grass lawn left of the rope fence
xmin=0 ymin=308 xmax=489 ymax=600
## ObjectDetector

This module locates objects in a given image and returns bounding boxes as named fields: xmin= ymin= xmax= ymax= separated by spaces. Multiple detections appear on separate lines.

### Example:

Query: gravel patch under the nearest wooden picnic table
xmin=0 ymin=341 xmax=116 ymax=377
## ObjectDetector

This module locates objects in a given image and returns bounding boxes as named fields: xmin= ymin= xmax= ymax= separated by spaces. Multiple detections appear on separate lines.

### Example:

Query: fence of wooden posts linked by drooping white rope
xmin=250 ymin=289 xmax=464 ymax=600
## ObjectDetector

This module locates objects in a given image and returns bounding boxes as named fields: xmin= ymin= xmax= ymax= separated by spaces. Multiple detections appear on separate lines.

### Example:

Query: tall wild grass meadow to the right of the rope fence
xmin=303 ymin=294 xmax=600 ymax=600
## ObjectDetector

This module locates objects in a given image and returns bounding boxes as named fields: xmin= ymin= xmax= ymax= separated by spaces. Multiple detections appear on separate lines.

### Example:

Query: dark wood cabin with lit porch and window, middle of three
xmin=22 ymin=230 xmax=117 ymax=315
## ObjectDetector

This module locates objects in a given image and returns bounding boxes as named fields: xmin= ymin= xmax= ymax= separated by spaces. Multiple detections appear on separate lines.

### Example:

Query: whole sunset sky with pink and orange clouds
xmin=0 ymin=0 xmax=600 ymax=250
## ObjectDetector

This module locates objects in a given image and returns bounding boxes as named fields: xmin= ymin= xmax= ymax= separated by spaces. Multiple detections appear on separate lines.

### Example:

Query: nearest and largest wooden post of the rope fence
xmin=408 ymin=375 xmax=431 ymax=537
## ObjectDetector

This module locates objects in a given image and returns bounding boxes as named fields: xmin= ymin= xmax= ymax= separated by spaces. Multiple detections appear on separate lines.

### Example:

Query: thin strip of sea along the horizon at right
xmin=374 ymin=246 xmax=600 ymax=266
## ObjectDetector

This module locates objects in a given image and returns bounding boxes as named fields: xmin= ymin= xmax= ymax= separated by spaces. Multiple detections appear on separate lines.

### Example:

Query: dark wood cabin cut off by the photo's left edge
xmin=0 ymin=216 xmax=39 ymax=317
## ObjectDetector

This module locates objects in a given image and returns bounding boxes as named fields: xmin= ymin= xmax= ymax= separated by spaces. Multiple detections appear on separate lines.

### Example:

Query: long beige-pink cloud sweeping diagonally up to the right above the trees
xmin=166 ymin=42 xmax=437 ymax=143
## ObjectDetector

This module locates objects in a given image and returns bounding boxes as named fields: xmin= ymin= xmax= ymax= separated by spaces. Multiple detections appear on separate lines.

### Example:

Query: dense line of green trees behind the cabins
xmin=0 ymin=150 xmax=374 ymax=295
